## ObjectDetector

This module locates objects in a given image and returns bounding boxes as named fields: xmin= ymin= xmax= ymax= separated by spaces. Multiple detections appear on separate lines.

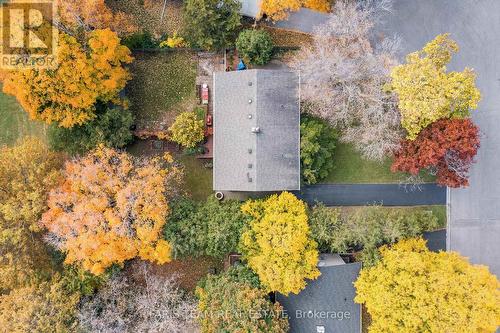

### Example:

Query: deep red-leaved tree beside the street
xmin=391 ymin=119 xmax=480 ymax=187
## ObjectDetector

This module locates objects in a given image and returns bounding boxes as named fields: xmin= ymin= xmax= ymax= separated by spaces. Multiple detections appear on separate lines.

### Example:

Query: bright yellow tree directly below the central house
xmin=240 ymin=192 xmax=320 ymax=295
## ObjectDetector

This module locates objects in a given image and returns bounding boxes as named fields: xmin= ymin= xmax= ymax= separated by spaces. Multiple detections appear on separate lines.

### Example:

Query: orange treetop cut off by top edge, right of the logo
xmin=56 ymin=0 xmax=137 ymax=36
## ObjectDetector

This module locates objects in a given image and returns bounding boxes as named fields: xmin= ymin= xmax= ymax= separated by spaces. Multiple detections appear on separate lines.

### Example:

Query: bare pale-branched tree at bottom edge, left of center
xmin=79 ymin=263 xmax=199 ymax=333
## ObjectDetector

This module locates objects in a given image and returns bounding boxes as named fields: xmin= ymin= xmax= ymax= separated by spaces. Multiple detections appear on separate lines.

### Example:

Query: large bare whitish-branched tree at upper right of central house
xmin=291 ymin=0 xmax=402 ymax=160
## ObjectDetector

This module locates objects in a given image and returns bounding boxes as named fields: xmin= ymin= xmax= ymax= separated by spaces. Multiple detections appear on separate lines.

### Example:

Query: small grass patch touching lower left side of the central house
xmin=176 ymin=155 xmax=213 ymax=201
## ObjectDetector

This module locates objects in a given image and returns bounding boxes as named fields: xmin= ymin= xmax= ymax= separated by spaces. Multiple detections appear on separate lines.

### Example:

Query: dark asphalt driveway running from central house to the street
xmin=296 ymin=184 xmax=446 ymax=206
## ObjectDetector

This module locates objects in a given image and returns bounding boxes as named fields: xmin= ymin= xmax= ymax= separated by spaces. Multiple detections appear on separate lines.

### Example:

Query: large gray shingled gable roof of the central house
xmin=213 ymin=69 xmax=300 ymax=192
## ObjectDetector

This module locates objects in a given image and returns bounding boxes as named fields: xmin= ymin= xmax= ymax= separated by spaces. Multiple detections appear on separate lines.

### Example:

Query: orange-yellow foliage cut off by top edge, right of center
xmin=260 ymin=0 xmax=330 ymax=21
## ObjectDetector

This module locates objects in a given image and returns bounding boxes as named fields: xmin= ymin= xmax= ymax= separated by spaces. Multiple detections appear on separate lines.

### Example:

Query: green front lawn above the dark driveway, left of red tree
xmin=322 ymin=142 xmax=434 ymax=184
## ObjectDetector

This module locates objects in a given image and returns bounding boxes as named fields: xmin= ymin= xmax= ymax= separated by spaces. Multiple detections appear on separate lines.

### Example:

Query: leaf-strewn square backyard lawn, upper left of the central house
xmin=126 ymin=51 xmax=196 ymax=127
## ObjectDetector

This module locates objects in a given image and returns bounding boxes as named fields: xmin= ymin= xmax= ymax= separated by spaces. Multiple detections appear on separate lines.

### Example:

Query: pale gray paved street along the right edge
xmin=380 ymin=0 xmax=500 ymax=276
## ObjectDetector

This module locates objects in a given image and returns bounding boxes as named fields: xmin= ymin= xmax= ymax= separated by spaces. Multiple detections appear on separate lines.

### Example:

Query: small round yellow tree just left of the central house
xmin=168 ymin=112 xmax=205 ymax=148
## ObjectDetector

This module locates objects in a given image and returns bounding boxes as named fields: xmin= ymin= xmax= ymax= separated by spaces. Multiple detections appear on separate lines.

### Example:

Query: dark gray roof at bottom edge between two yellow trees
xmin=276 ymin=262 xmax=361 ymax=333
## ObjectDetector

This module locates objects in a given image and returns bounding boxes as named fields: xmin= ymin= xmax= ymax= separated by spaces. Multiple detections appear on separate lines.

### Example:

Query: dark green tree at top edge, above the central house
xmin=184 ymin=0 xmax=241 ymax=50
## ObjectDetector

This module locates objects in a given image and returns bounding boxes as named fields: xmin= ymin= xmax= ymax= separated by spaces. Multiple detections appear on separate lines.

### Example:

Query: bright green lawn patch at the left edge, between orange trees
xmin=0 ymin=85 xmax=46 ymax=146
